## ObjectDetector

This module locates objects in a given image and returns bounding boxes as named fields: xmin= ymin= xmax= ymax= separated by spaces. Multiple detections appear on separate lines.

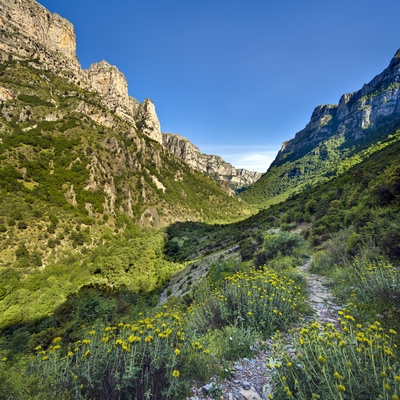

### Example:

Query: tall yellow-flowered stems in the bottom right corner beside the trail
xmin=268 ymin=314 xmax=400 ymax=400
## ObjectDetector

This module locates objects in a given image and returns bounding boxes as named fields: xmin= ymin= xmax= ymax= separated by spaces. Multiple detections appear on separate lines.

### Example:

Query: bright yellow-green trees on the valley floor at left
xmin=0 ymin=226 xmax=181 ymax=328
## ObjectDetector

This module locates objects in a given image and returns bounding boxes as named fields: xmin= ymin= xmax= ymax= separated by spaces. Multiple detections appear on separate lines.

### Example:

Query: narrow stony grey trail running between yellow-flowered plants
xmin=189 ymin=259 xmax=342 ymax=400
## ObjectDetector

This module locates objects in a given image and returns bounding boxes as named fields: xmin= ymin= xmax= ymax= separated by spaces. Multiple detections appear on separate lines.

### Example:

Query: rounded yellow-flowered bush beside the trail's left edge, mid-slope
xmin=188 ymin=268 xmax=304 ymax=337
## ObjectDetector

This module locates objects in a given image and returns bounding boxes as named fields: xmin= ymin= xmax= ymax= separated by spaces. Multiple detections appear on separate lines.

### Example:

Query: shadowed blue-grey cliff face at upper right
xmin=271 ymin=50 xmax=400 ymax=167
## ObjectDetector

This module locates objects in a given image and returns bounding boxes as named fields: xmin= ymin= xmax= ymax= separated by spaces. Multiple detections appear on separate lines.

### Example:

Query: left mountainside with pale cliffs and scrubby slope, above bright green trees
xmin=0 ymin=0 xmax=250 ymax=227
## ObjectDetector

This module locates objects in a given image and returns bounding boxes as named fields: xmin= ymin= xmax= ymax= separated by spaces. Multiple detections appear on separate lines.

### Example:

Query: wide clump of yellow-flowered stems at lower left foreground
xmin=31 ymin=306 xmax=208 ymax=399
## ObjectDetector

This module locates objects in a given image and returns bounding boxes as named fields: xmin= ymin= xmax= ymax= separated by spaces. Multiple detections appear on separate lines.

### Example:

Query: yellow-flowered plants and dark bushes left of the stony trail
xmin=0 ymin=256 xmax=304 ymax=399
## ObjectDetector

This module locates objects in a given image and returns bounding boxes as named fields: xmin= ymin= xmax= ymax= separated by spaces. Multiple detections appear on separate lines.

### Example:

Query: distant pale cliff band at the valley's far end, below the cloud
xmin=162 ymin=133 xmax=261 ymax=191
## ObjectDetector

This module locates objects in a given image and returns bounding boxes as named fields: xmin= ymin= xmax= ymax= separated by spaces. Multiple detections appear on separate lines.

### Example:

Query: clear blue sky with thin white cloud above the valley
xmin=39 ymin=0 xmax=400 ymax=172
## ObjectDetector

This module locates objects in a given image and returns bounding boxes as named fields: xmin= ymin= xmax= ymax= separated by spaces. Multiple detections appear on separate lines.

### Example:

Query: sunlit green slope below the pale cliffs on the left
xmin=0 ymin=60 xmax=250 ymax=327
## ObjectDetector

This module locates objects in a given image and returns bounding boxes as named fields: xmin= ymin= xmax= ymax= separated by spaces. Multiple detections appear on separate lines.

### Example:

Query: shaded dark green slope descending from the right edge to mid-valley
xmin=167 ymin=126 xmax=400 ymax=262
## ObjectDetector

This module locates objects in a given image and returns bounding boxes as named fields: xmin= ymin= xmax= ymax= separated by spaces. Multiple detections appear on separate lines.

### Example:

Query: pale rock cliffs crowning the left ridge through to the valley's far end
xmin=0 ymin=0 xmax=253 ymax=203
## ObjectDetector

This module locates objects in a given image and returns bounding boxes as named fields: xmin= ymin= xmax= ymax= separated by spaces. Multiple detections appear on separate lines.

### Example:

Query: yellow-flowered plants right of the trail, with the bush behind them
xmin=268 ymin=260 xmax=400 ymax=399
